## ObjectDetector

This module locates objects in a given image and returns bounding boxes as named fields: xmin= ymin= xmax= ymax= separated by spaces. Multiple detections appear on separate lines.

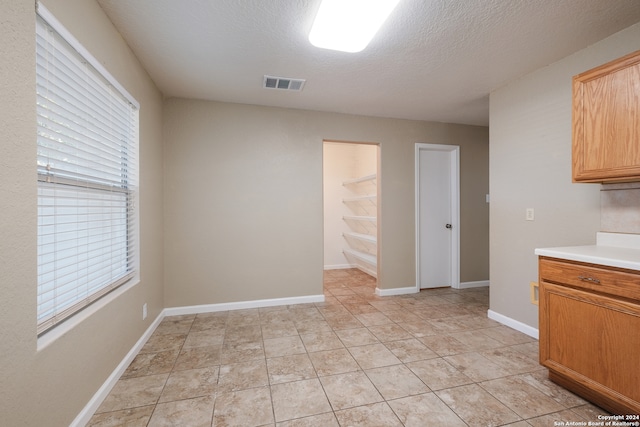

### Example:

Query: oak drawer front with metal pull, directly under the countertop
xmin=539 ymin=257 xmax=640 ymax=301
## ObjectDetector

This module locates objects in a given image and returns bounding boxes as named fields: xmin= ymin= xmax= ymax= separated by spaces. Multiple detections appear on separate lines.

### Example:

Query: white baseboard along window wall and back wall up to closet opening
xmin=69 ymin=295 xmax=324 ymax=427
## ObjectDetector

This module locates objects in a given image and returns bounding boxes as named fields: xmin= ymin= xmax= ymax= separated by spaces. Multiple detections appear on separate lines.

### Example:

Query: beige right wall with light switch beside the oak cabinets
xmin=490 ymin=20 xmax=640 ymax=328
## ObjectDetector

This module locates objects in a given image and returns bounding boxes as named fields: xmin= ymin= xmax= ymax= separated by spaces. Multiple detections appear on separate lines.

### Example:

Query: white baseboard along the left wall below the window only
xmin=69 ymin=310 xmax=165 ymax=427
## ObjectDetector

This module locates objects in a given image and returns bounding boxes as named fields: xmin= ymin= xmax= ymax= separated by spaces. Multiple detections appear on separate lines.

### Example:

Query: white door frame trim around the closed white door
xmin=415 ymin=143 xmax=460 ymax=292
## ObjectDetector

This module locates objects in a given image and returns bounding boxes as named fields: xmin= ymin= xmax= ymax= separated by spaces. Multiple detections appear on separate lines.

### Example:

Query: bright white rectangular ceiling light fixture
xmin=309 ymin=0 xmax=400 ymax=53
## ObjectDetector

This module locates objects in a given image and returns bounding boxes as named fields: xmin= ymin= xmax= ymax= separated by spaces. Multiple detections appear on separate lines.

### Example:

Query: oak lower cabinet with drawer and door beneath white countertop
xmin=539 ymin=257 xmax=640 ymax=415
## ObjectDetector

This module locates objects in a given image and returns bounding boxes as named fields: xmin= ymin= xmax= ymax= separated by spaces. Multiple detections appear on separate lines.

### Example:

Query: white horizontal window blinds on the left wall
xmin=36 ymin=5 xmax=138 ymax=333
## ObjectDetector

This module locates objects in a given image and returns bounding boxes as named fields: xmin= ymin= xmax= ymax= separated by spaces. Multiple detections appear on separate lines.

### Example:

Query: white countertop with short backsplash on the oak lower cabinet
xmin=535 ymin=232 xmax=640 ymax=271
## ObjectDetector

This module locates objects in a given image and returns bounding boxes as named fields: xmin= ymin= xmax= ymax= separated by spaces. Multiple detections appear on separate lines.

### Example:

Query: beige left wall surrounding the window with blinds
xmin=0 ymin=0 xmax=163 ymax=426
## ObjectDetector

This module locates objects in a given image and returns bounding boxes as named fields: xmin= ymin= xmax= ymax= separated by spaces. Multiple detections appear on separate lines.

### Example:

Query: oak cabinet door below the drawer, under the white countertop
xmin=540 ymin=281 xmax=640 ymax=413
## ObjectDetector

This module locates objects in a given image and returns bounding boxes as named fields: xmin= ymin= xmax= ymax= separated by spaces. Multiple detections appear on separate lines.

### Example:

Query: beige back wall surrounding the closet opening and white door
xmin=163 ymin=99 xmax=488 ymax=307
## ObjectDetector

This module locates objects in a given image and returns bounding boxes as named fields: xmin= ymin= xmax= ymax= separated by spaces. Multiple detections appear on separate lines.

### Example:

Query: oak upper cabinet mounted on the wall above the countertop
xmin=573 ymin=51 xmax=640 ymax=182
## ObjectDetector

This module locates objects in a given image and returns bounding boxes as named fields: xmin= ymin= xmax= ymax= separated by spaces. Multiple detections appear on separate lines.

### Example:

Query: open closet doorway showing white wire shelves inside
xmin=323 ymin=140 xmax=380 ymax=298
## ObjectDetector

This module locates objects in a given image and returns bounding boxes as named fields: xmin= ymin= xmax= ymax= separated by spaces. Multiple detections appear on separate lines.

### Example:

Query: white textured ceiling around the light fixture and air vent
xmin=98 ymin=0 xmax=640 ymax=125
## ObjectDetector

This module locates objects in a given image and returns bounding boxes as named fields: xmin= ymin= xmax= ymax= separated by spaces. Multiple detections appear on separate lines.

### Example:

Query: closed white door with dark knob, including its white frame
xmin=416 ymin=144 xmax=459 ymax=289
